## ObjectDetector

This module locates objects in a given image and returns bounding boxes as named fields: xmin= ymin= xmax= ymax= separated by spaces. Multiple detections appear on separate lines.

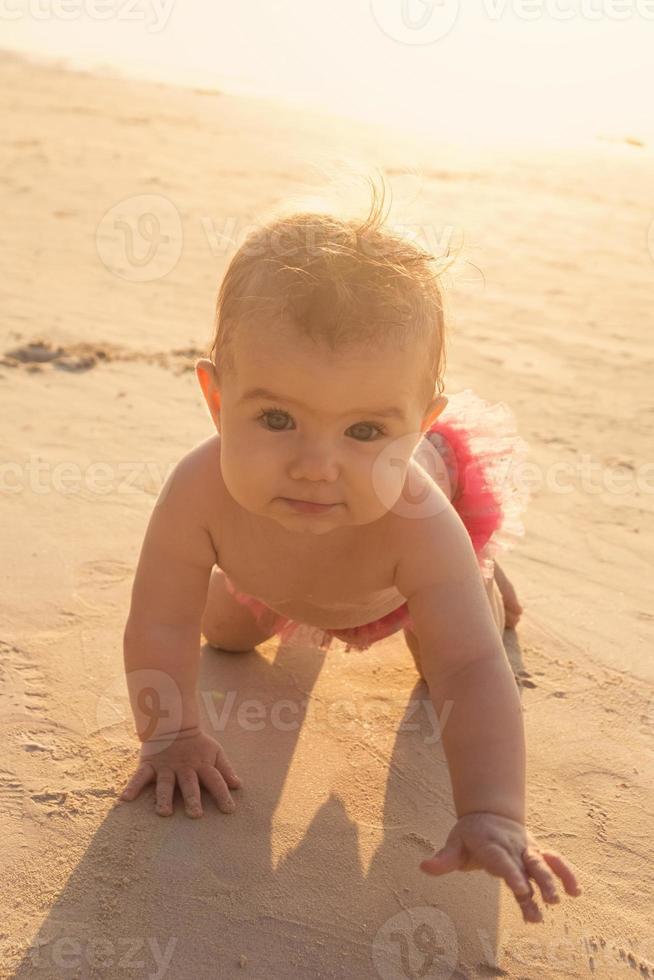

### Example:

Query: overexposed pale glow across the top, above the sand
xmin=2 ymin=0 xmax=654 ymax=144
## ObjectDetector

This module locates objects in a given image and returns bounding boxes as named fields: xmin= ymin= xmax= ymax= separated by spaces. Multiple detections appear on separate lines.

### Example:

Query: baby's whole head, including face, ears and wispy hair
xmin=196 ymin=172 xmax=458 ymax=534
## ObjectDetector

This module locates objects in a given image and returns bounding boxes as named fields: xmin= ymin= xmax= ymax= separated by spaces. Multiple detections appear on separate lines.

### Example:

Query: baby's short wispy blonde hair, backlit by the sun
xmin=209 ymin=165 xmax=456 ymax=406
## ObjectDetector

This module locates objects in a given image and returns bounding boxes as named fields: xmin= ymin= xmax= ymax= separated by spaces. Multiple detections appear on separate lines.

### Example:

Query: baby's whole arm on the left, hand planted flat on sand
xmin=122 ymin=444 xmax=240 ymax=816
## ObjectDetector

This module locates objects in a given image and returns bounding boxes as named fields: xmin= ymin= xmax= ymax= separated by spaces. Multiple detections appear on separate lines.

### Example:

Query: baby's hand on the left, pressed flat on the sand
xmin=120 ymin=728 xmax=241 ymax=817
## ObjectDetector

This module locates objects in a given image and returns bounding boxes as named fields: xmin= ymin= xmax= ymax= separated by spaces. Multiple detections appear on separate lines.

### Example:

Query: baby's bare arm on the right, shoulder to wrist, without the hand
xmin=398 ymin=508 xmax=525 ymax=822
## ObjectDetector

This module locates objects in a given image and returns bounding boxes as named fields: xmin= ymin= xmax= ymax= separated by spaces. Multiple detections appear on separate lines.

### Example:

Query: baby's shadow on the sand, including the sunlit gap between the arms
xmin=13 ymin=630 xmax=523 ymax=980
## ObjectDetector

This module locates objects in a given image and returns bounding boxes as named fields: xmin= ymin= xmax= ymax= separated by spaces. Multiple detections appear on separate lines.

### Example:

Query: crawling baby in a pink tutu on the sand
xmin=121 ymin=180 xmax=581 ymax=922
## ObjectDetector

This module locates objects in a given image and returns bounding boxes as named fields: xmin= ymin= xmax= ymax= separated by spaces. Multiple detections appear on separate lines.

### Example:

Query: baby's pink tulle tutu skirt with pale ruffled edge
xmin=225 ymin=388 xmax=530 ymax=650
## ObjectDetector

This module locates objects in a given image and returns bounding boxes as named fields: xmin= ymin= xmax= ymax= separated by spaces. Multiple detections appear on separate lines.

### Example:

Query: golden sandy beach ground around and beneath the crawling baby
xmin=0 ymin=56 xmax=654 ymax=980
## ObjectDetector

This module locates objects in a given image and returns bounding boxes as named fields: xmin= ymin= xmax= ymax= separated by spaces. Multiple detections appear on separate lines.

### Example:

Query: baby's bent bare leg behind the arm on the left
xmin=200 ymin=565 xmax=274 ymax=653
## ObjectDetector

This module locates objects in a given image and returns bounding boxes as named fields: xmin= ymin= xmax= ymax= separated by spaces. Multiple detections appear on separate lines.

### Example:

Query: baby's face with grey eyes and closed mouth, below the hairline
xmin=196 ymin=327 xmax=444 ymax=535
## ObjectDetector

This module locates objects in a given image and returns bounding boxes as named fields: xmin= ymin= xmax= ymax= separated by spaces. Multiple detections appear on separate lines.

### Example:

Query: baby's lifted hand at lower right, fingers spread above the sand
xmin=420 ymin=812 xmax=581 ymax=922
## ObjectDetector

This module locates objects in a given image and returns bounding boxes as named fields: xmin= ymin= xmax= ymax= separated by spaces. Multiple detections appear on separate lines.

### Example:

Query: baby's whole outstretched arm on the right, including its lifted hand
xmin=396 ymin=488 xmax=579 ymax=922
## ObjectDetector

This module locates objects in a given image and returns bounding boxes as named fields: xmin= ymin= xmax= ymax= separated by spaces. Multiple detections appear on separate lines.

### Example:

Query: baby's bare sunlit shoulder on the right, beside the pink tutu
xmin=394 ymin=458 xmax=477 ymax=599
